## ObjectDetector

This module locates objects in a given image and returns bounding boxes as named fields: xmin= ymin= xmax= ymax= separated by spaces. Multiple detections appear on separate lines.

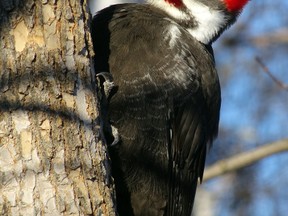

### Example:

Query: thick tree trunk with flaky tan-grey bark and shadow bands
xmin=0 ymin=0 xmax=115 ymax=216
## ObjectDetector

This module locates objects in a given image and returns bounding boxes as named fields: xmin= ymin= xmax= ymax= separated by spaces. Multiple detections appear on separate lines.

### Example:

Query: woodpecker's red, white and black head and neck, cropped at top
xmin=147 ymin=0 xmax=249 ymax=44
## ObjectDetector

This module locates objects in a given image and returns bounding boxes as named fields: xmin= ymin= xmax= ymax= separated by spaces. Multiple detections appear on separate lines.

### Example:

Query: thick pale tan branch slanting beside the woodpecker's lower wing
xmin=203 ymin=139 xmax=288 ymax=181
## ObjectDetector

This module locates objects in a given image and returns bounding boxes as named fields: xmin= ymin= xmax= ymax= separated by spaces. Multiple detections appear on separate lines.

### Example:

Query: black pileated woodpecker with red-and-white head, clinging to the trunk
xmin=91 ymin=0 xmax=248 ymax=216
